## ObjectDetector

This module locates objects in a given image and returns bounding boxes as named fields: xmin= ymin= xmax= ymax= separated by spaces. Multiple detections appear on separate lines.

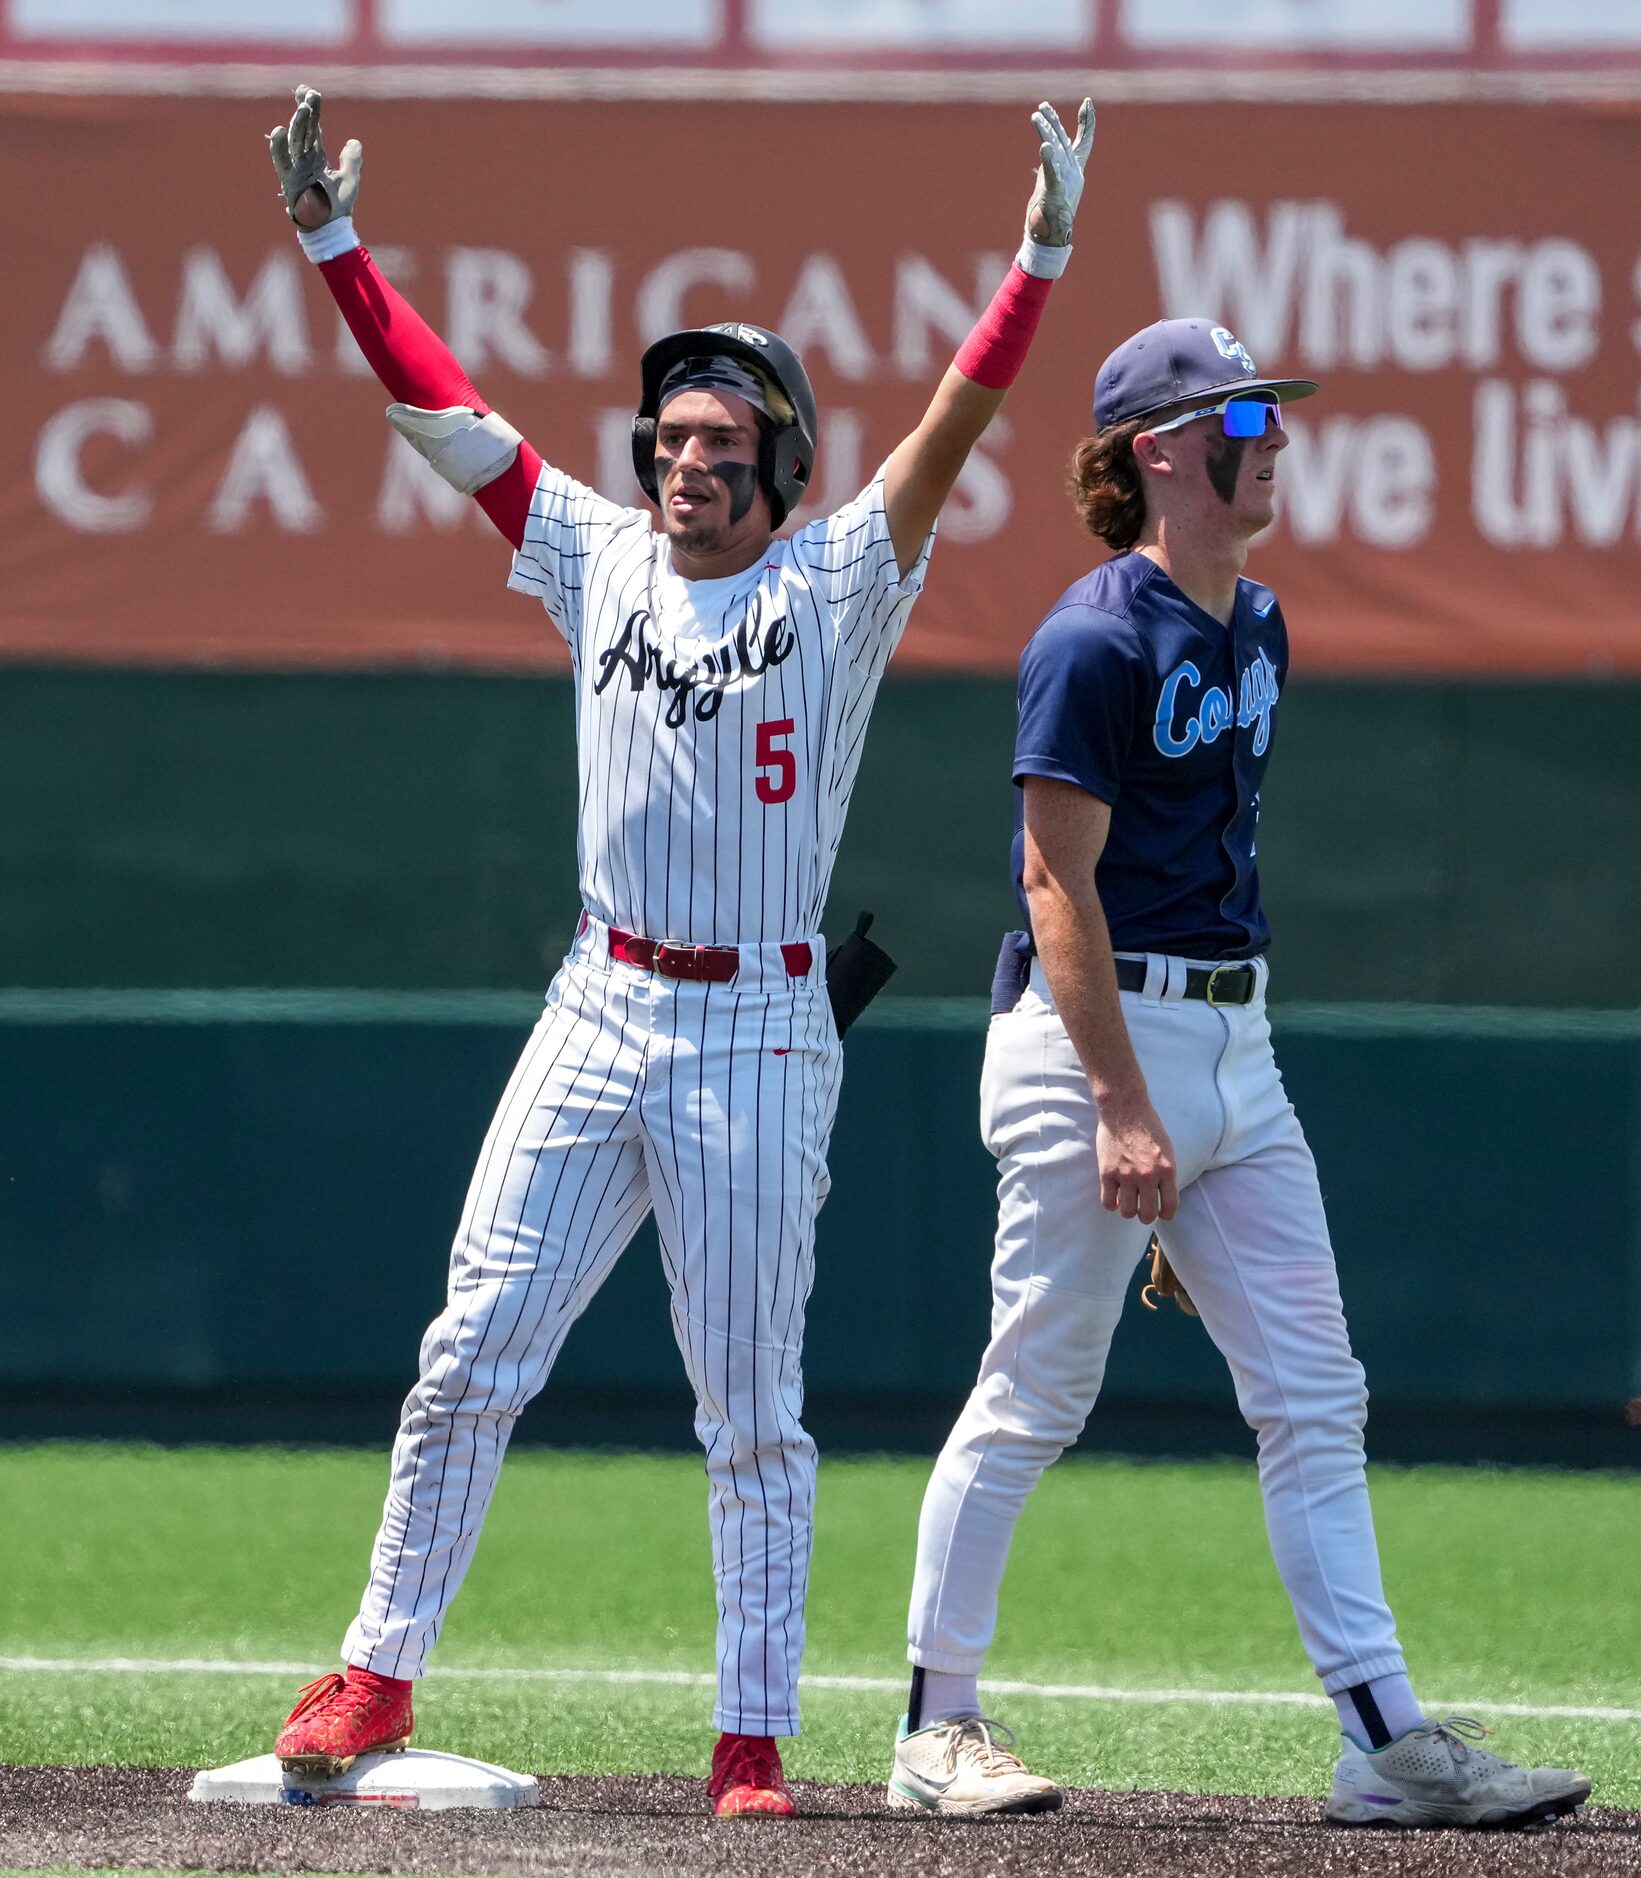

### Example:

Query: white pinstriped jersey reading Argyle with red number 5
xmin=507 ymin=466 xmax=933 ymax=945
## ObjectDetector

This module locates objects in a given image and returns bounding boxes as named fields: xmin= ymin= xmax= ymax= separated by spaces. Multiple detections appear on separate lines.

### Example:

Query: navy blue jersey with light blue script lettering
xmin=1014 ymin=554 xmax=1288 ymax=958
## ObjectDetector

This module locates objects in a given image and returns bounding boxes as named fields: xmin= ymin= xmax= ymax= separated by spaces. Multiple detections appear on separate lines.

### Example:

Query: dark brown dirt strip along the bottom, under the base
xmin=0 ymin=1767 xmax=1641 ymax=1878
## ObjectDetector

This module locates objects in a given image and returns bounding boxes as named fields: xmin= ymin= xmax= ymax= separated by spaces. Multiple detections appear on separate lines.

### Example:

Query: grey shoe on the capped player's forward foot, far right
xmin=1326 ymin=1715 xmax=1590 ymax=1827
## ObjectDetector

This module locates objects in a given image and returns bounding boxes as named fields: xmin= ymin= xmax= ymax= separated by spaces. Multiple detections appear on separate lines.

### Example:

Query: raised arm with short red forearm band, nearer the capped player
xmin=882 ymin=98 xmax=1095 ymax=575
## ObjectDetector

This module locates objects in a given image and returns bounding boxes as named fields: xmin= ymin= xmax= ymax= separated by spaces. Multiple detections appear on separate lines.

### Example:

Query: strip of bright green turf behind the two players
xmin=0 ymin=1444 xmax=1641 ymax=1807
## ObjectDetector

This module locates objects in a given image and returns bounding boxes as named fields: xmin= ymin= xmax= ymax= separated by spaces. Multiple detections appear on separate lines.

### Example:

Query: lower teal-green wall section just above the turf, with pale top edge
xmin=0 ymin=990 xmax=1641 ymax=1461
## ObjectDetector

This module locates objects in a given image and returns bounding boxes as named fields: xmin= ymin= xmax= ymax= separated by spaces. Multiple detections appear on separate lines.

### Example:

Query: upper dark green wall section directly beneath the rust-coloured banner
xmin=0 ymin=667 xmax=1641 ymax=1008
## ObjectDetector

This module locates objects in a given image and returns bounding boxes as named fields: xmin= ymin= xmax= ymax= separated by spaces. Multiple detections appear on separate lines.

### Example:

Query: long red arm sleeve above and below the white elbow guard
xmin=319 ymin=248 xmax=541 ymax=548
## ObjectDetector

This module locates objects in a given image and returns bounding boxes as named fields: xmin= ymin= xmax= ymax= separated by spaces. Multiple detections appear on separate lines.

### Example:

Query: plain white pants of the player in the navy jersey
xmin=909 ymin=956 xmax=1403 ymax=1694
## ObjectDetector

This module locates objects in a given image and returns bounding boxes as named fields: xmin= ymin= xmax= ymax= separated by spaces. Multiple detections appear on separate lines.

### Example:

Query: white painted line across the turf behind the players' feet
xmin=0 ymin=1656 xmax=1641 ymax=1724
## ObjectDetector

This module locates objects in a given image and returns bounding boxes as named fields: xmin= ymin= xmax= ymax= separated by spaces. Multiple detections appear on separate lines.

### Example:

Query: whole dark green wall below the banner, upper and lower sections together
xmin=0 ymin=667 xmax=1641 ymax=1461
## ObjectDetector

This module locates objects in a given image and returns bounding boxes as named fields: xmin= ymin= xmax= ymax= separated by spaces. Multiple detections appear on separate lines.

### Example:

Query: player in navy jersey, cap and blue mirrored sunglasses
xmin=888 ymin=319 xmax=1590 ymax=1827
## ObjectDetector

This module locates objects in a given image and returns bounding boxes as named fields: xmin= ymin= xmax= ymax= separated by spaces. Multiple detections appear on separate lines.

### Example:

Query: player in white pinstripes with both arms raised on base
xmin=259 ymin=88 xmax=1093 ymax=1814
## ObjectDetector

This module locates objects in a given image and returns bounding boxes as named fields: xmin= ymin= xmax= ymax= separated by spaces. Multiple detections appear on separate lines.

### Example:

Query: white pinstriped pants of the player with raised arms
xmin=342 ymin=922 xmax=843 ymax=1735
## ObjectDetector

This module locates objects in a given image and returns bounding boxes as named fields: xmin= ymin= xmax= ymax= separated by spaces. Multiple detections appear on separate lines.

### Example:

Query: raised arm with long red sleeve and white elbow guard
xmin=268 ymin=85 xmax=541 ymax=548
